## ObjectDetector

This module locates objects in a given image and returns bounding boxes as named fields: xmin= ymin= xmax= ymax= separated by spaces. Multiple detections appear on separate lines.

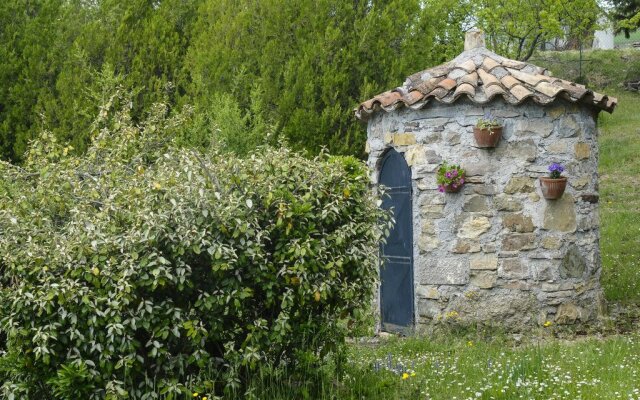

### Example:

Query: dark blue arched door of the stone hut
xmin=378 ymin=149 xmax=414 ymax=332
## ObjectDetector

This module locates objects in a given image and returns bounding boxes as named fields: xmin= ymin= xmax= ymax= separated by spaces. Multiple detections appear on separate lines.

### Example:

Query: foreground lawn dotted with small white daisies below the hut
xmin=344 ymin=334 xmax=640 ymax=400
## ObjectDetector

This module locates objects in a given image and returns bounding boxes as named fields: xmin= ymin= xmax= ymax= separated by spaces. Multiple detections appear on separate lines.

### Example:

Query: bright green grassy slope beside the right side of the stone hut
xmin=599 ymin=90 xmax=640 ymax=304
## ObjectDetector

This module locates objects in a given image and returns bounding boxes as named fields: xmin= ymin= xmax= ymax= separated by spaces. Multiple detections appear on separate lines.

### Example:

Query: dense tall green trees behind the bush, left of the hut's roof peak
xmin=0 ymin=0 xmax=466 ymax=162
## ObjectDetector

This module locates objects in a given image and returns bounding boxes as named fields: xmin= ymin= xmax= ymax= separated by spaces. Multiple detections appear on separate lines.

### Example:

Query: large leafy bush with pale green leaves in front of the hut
xmin=0 ymin=100 xmax=387 ymax=399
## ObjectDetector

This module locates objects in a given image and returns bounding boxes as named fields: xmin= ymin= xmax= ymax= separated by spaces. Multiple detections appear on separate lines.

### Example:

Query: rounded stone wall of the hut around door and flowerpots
xmin=367 ymin=99 xmax=603 ymax=329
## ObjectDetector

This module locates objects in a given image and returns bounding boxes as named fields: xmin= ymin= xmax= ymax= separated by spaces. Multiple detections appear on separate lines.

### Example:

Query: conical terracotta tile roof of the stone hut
xmin=355 ymin=47 xmax=618 ymax=120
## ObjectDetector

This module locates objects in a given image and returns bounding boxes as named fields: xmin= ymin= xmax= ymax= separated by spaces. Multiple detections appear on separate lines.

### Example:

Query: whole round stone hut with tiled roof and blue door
xmin=355 ymin=31 xmax=617 ymax=331
